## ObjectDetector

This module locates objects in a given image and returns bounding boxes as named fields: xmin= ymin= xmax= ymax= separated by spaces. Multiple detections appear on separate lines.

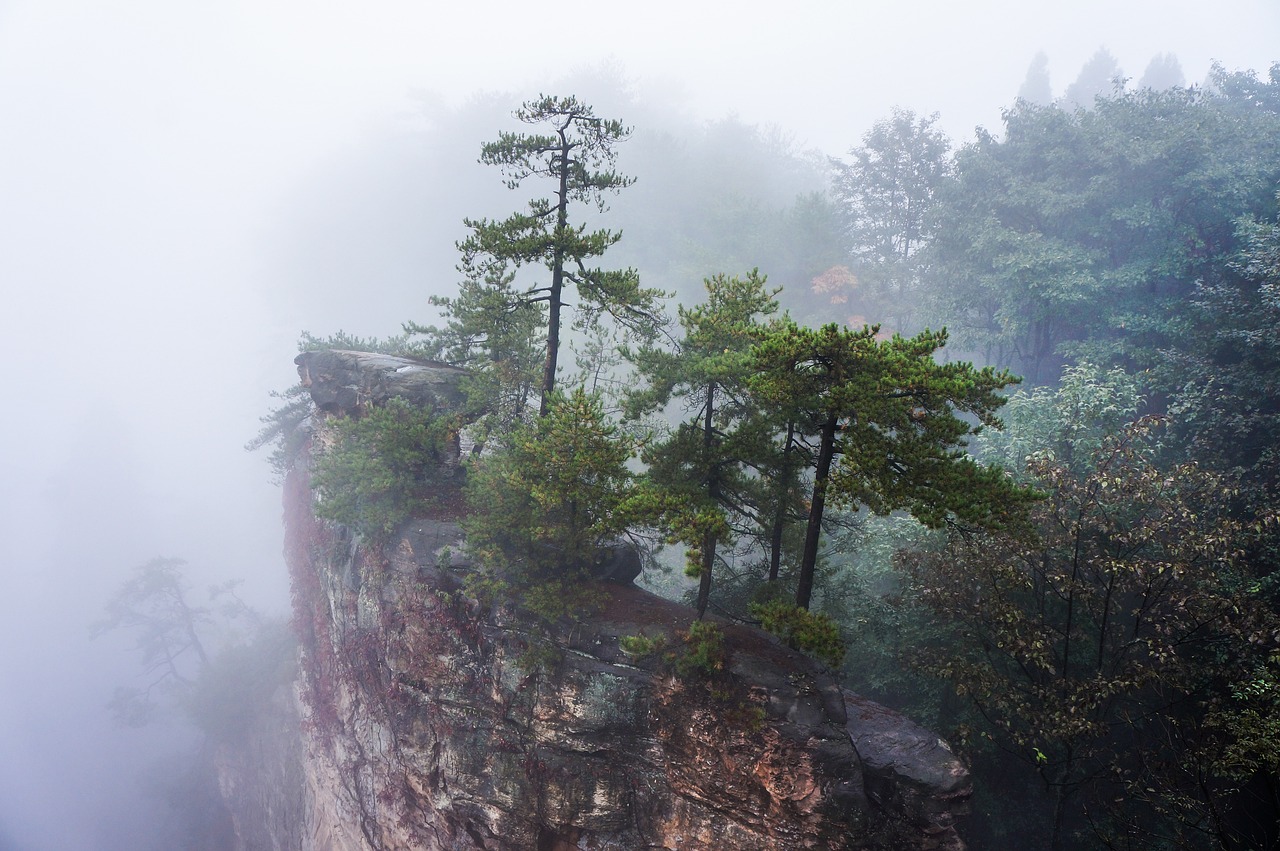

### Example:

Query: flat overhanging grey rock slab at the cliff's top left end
xmin=293 ymin=349 xmax=466 ymax=413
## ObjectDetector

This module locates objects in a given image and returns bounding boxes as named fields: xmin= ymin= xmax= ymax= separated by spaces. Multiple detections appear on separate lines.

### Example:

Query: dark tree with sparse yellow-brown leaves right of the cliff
xmin=908 ymin=420 xmax=1280 ymax=836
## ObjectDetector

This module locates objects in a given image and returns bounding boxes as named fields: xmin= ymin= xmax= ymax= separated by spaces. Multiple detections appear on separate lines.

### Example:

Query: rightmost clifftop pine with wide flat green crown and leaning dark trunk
xmin=751 ymin=314 xmax=1033 ymax=608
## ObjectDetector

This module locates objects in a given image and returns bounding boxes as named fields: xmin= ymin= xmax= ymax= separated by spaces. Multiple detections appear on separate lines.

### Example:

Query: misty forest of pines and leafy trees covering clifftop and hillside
xmin=251 ymin=64 xmax=1280 ymax=850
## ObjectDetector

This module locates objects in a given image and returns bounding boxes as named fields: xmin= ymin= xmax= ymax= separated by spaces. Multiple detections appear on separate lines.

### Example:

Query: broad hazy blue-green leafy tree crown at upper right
xmin=927 ymin=81 xmax=1280 ymax=384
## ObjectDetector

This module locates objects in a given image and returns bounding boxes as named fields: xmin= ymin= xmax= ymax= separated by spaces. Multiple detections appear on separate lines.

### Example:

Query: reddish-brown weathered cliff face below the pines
xmin=223 ymin=348 xmax=969 ymax=851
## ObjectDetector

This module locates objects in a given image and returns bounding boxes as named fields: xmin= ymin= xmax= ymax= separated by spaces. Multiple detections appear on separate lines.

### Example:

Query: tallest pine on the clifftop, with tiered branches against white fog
xmin=433 ymin=96 xmax=662 ymax=416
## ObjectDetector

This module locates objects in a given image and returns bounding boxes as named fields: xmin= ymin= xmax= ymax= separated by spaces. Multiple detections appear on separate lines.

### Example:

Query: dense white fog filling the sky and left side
xmin=0 ymin=0 xmax=1280 ymax=851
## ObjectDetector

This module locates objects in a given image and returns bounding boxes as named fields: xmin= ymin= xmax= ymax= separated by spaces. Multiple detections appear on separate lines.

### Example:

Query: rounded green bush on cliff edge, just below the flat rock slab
xmin=311 ymin=399 xmax=460 ymax=537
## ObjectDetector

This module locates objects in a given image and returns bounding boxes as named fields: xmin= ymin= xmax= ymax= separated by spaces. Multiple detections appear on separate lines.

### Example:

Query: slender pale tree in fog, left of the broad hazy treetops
xmin=832 ymin=109 xmax=951 ymax=330
